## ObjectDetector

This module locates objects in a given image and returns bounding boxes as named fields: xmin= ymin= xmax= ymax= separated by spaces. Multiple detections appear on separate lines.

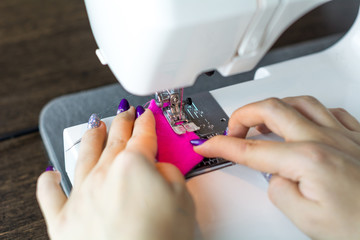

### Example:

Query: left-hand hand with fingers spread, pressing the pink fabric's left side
xmin=37 ymin=104 xmax=195 ymax=240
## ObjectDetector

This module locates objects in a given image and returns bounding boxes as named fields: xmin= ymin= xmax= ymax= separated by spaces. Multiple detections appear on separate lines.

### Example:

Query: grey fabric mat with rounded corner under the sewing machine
xmin=39 ymin=35 xmax=341 ymax=194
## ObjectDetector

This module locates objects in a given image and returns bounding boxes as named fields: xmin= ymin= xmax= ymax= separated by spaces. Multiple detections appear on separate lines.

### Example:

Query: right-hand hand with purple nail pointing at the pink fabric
xmin=195 ymin=96 xmax=360 ymax=239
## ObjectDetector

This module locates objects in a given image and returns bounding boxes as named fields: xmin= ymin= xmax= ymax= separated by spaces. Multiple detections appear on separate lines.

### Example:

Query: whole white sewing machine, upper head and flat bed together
xmin=64 ymin=0 xmax=360 ymax=239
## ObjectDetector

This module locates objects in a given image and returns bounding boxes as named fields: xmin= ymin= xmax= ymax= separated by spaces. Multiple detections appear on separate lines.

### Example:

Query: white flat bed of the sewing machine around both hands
xmin=64 ymin=0 xmax=360 ymax=239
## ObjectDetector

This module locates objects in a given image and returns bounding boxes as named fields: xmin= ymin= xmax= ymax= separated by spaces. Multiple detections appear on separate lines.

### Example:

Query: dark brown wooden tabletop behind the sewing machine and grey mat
xmin=0 ymin=0 xmax=358 ymax=239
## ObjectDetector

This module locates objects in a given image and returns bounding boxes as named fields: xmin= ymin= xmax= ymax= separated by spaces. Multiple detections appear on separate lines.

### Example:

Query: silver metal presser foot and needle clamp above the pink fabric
xmin=155 ymin=89 xmax=200 ymax=135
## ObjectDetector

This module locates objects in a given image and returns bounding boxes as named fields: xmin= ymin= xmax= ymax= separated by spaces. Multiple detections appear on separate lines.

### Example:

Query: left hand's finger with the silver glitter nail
xmin=74 ymin=122 xmax=106 ymax=189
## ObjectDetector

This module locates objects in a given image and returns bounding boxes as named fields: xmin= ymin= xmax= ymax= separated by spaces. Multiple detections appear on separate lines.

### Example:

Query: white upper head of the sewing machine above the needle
xmin=85 ymin=0 xmax=328 ymax=95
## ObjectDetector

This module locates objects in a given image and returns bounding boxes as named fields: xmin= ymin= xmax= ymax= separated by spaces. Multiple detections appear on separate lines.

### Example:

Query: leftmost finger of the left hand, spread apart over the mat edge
xmin=36 ymin=171 xmax=67 ymax=225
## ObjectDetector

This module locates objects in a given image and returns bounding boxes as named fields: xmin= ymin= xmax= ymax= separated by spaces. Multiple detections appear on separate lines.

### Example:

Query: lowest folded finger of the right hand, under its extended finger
xmin=268 ymin=176 xmax=318 ymax=230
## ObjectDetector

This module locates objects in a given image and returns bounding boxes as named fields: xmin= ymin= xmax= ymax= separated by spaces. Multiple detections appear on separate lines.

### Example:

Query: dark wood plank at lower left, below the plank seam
xmin=0 ymin=133 xmax=47 ymax=239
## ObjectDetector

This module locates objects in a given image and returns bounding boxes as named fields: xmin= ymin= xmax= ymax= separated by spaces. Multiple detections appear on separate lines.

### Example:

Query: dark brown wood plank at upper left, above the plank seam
xmin=0 ymin=0 xmax=116 ymax=139
